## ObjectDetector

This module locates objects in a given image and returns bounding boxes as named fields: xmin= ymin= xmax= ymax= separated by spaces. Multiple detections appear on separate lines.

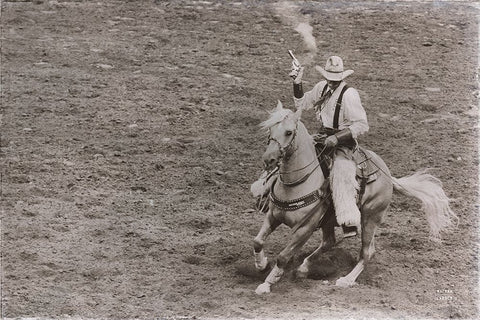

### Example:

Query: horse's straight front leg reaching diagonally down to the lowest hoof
xmin=255 ymin=210 xmax=320 ymax=295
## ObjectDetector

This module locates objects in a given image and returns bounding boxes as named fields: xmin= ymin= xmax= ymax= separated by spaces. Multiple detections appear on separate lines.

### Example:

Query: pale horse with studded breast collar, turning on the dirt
xmin=252 ymin=101 xmax=456 ymax=294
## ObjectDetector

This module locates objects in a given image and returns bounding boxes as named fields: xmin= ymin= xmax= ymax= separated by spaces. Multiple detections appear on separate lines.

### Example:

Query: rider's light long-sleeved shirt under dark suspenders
xmin=293 ymin=81 xmax=368 ymax=139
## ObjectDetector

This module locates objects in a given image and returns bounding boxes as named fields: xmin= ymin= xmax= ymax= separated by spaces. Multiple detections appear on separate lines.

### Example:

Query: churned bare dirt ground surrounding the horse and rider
xmin=0 ymin=0 xmax=479 ymax=319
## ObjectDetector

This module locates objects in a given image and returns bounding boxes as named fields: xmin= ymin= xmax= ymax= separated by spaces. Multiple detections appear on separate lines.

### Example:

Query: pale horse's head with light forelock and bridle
xmin=261 ymin=101 xmax=301 ymax=171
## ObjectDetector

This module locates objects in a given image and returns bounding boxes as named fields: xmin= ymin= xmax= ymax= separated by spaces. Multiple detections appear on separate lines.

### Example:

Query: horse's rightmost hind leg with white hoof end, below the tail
xmin=335 ymin=210 xmax=385 ymax=287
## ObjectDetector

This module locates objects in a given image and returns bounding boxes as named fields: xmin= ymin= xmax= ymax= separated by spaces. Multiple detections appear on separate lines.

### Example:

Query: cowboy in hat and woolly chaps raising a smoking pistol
xmin=290 ymin=56 xmax=368 ymax=237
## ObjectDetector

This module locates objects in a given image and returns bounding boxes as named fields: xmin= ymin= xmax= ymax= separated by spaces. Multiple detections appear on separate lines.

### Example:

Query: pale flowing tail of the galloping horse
xmin=392 ymin=170 xmax=458 ymax=241
